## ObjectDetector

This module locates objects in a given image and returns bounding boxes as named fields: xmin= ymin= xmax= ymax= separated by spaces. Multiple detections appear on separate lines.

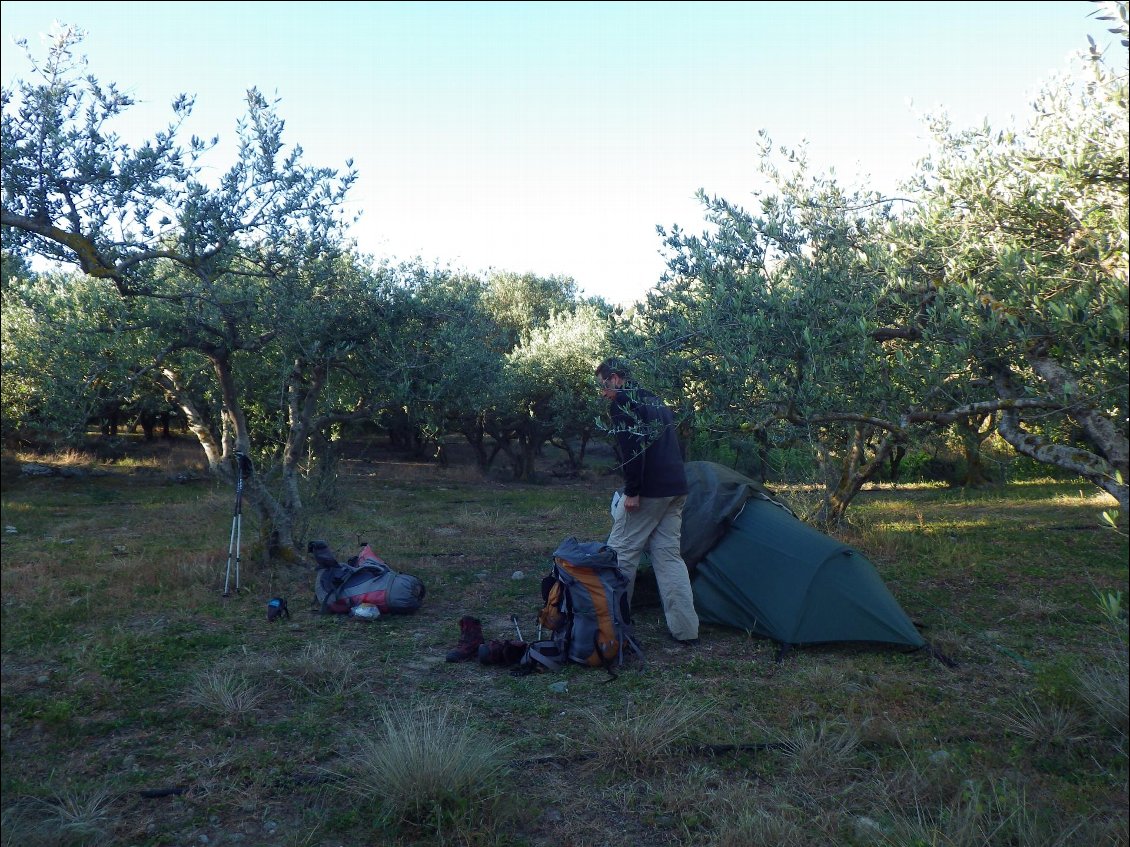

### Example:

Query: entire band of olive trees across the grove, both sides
xmin=0 ymin=11 xmax=1130 ymax=550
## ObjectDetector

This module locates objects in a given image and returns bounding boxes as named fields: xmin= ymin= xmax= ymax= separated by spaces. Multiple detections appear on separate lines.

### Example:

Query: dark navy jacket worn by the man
xmin=610 ymin=383 xmax=688 ymax=497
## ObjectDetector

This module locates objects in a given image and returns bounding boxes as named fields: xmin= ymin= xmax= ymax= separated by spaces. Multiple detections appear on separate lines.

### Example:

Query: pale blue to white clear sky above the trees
xmin=0 ymin=0 xmax=1113 ymax=302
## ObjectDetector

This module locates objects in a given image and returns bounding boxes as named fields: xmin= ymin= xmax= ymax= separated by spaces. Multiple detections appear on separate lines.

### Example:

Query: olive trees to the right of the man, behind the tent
xmin=618 ymin=16 xmax=1128 ymax=523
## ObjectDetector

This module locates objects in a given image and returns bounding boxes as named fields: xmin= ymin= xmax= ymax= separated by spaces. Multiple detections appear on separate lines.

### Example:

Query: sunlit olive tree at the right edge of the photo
xmin=895 ymin=33 xmax=1130 ymax=510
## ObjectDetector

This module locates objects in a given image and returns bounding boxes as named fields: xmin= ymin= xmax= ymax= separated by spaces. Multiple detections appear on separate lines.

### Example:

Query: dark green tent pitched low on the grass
xmin=683 ymin=462 xmax=927 ymax=648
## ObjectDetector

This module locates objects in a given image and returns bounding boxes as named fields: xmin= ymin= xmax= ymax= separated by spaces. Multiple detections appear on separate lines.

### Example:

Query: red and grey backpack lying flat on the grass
xmin=310 ymin=542 xmax=425 ymax=614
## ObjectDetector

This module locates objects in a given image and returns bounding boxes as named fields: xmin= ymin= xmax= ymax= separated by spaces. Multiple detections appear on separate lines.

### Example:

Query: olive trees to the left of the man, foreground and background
xmin=2 ymin=27 xmax=600 ymax=552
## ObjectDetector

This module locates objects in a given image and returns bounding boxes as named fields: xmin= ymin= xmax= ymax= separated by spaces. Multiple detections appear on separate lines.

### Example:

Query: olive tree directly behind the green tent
xmin=631 ymin=151 xmax=953 ymax=522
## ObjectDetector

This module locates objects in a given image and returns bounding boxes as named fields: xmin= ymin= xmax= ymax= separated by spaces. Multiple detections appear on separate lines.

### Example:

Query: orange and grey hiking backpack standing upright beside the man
xmin=522 ymin=538 xmax=643 ymax=673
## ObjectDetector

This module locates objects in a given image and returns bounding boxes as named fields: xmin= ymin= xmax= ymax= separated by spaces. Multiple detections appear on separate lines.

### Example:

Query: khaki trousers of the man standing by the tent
xmin=608 ymin=496 xmax=698 ymax=641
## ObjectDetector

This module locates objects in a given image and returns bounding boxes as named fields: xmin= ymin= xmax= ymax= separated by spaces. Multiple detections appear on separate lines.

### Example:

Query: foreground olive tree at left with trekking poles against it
xmin=0 ymin=27 xmax=380 ymax=549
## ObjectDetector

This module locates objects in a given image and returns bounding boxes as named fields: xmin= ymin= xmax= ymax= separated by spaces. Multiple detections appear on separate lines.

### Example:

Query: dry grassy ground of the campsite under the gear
xmin=2 ymin=438 xmax=1130 ymax=847
